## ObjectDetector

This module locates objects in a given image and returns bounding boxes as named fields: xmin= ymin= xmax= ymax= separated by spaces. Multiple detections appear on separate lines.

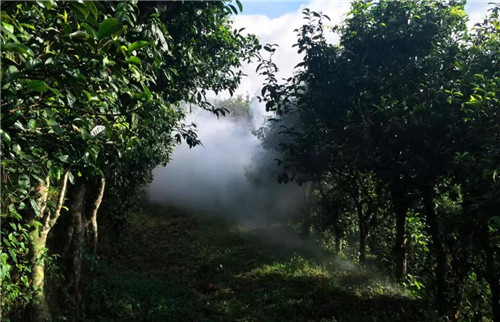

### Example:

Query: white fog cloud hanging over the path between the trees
xmin=148 ymin=104 xmax=302 ymax=225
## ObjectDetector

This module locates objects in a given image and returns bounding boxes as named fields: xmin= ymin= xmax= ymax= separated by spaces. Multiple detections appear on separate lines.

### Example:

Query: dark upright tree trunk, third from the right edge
xmin=391 ymin=185 xmax=408 ymax=278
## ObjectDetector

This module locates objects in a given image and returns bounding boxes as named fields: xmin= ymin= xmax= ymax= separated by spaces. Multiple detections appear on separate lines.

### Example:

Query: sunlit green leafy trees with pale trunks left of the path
xmin=1 ymin=1 xmax=258 ymax=320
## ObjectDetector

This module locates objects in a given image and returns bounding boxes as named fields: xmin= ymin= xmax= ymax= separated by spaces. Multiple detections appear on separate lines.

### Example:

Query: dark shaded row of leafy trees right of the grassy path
xmin=258 ymin=0 xmax=500 ymax=320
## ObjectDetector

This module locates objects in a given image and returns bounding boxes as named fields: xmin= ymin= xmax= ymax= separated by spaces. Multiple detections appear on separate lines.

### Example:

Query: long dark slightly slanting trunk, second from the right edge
xmin=421 ymin=186 xmax=449 ymax=316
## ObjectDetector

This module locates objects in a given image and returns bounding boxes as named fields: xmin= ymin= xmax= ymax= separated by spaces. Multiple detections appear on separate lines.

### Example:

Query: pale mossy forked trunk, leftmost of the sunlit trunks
xmin=29 ymin=171 xmax=69 ymax=322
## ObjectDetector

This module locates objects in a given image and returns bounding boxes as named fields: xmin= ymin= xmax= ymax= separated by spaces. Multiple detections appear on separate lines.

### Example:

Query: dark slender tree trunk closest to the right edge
xmin=477 ymin=211 xmax=500 ymax=321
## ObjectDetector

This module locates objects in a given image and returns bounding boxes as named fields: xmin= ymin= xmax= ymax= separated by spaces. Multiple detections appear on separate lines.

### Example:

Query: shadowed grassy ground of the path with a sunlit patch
xmin=86 ymin=207 xmax=427 ymax=321
